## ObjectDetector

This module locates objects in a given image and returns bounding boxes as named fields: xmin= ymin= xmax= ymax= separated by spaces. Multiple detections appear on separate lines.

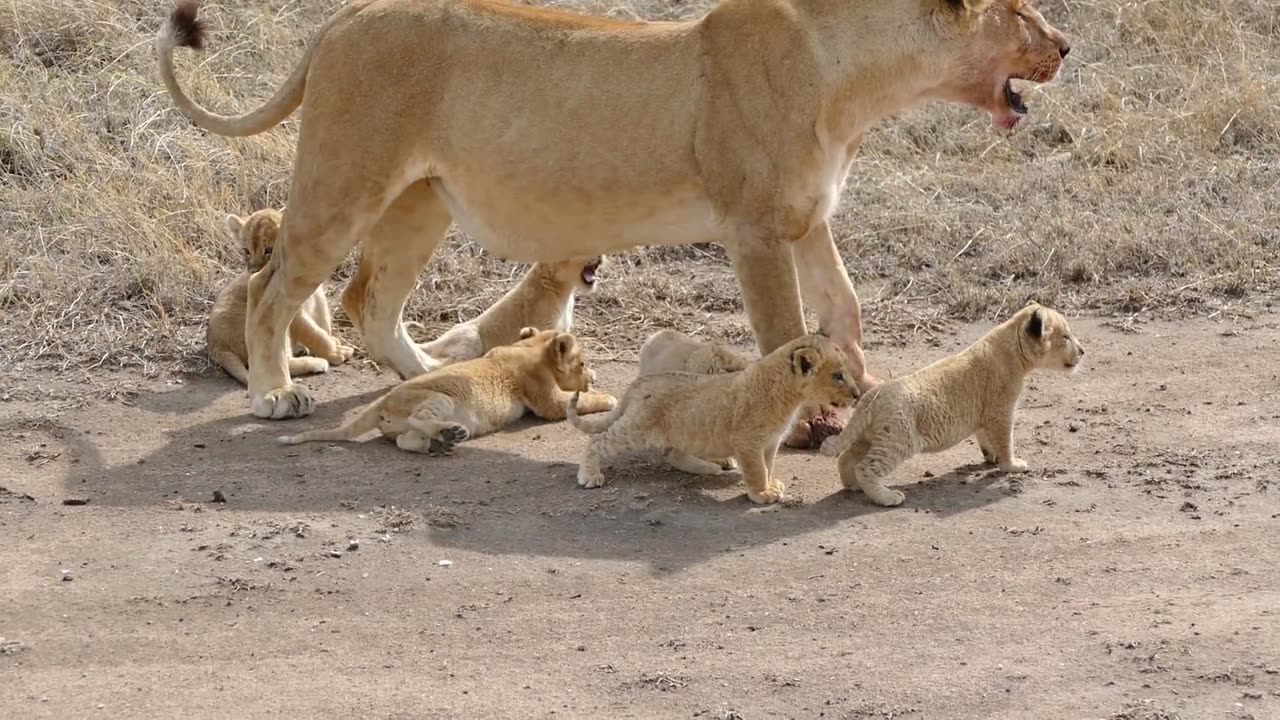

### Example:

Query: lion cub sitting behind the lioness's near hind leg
xmin=205 ymin=209 xmax=353 ymax=386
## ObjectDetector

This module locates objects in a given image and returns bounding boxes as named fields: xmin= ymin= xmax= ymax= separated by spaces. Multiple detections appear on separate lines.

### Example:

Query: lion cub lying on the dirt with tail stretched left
xmin=280 ymin=328 xmax=617 ymax=455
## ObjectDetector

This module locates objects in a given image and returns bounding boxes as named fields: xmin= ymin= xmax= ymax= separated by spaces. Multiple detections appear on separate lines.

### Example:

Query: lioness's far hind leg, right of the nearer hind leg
xmin=342 ymin=179 xmax=452 ymax=379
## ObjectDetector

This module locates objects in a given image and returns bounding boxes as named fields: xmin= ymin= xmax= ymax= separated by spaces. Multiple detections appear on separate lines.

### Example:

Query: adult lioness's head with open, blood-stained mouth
xmin=919 ymin=0 xmax=1071 ymax=129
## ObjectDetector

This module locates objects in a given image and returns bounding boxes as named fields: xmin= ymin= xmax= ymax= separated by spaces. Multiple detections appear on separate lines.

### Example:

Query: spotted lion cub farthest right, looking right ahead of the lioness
xmin=822 ymin=302 xmax=1084 ymax=506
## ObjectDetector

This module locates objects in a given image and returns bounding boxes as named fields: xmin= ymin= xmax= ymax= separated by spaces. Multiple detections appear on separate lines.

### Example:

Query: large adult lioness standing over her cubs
xmin=156 ymin=0 xmax=1069 ymax=446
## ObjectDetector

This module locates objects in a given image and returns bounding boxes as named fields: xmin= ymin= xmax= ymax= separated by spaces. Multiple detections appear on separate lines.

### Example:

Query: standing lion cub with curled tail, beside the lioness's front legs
xmin=568 ymin=334 xmax=858 ymax=505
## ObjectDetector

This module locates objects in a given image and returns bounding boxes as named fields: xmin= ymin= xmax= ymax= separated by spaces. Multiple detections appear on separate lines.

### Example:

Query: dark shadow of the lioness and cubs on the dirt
xmin=60 ymin=378 xmax=1009 ymax=571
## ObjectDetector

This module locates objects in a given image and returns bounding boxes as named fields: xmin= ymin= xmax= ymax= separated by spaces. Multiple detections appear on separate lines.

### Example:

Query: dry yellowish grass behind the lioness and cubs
xmin=0 ymin=0 xmax=1280 ymax=369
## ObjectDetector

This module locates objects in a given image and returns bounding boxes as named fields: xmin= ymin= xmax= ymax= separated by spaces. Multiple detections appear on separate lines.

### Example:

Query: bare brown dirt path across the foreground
xmin=0 ymin=316 xmax=1280 ymax=719
